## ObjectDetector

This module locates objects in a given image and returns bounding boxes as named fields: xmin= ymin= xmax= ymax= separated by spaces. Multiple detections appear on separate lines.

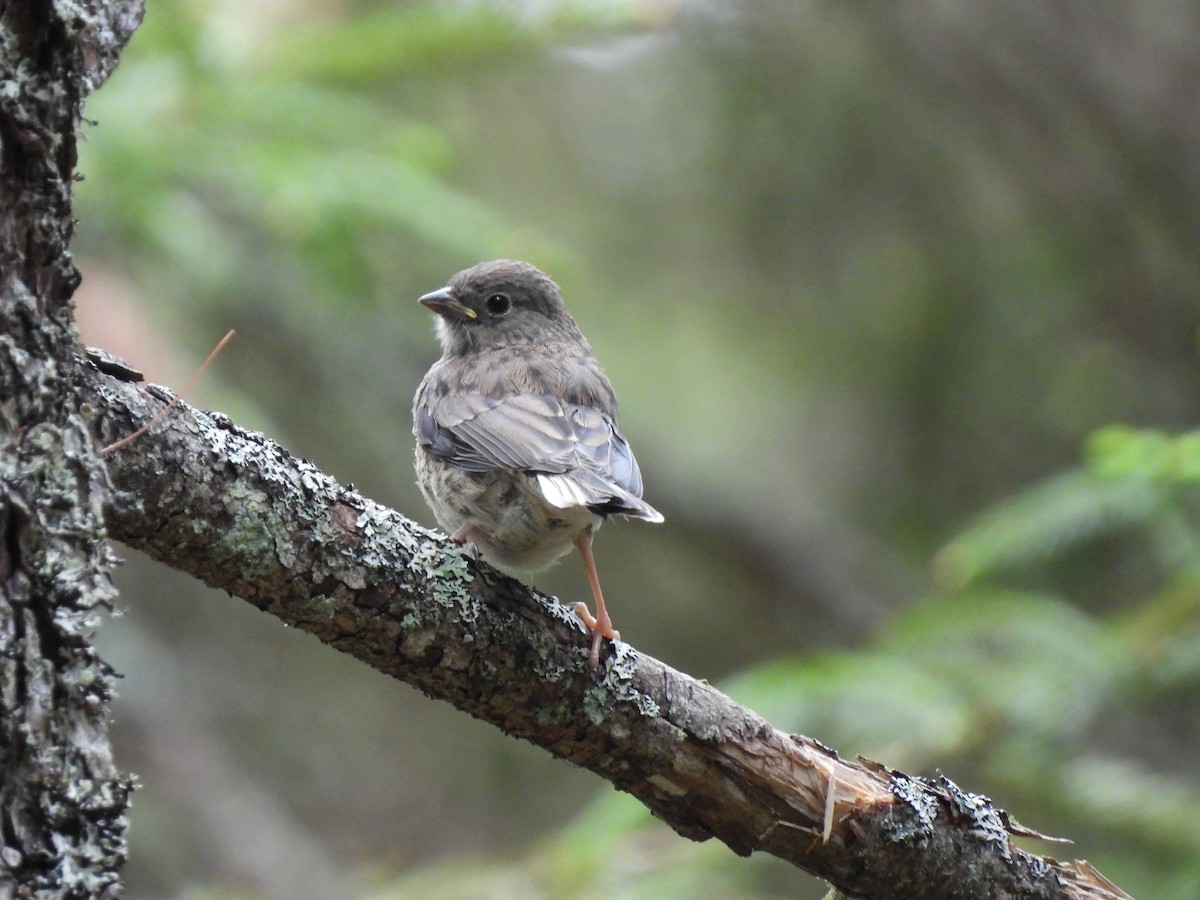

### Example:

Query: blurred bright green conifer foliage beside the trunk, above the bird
xmin=80 ymin=2 xmax=635 ymax=324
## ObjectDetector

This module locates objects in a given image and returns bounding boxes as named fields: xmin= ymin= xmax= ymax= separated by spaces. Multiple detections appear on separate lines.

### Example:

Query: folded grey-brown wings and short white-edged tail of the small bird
xmin=415 ymin=394 xmax=662 ymax=522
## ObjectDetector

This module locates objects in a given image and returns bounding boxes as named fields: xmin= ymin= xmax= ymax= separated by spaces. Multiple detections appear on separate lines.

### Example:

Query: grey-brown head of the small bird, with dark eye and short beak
xmin=419 ymin=259 xmax=582 ymax=356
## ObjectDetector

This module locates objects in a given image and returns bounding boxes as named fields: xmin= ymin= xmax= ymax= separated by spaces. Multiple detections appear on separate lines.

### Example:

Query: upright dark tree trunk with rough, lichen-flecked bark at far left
xmin=0 ymin=0 xmax=142 ymax=898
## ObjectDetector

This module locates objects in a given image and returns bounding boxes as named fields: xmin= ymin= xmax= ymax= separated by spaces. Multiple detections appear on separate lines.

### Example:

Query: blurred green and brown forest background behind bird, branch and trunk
xmin=76 ymin=0 xmax=1200 ymax=900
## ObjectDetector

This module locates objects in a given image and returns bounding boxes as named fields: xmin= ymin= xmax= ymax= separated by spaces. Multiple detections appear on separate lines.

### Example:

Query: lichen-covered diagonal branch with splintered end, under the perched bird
xmin=74 ymin=360 xmax=1127 ymax=899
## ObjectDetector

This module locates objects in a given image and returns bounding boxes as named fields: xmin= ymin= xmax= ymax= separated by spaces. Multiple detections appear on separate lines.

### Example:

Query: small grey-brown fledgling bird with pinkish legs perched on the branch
xmin=413 ymin=259 xmax=662 ymax=667
